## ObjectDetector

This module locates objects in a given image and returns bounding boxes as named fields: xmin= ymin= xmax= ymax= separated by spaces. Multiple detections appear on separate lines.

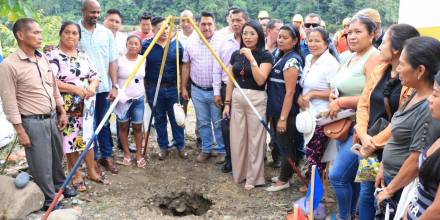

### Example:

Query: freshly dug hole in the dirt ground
xmin=153 ymin=192 xmax=213 ymax=216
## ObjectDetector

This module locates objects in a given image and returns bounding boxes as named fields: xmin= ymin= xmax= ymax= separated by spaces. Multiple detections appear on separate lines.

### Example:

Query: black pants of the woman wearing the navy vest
xmin=272 ymin=117 xmax=302 ymax=182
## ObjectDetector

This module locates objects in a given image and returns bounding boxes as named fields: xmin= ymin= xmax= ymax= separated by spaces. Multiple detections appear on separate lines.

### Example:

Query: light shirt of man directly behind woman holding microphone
xmin=212 ymin=33 xmax=240 ymax=96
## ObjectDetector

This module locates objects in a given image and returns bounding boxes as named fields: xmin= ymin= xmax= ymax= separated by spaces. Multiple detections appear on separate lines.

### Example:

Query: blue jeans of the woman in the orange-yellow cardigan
xmin=359 ymin=181 xmax=376 ymax=220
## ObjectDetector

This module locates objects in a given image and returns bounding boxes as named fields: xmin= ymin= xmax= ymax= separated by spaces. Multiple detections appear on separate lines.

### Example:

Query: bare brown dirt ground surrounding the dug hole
xmin=20 ymin=103 xmax=336 ymax=219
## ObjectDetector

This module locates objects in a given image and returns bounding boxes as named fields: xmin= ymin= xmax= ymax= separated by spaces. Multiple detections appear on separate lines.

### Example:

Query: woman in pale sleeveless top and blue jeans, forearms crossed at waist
xmin=327 ymin=16 xmax=378 ymax=219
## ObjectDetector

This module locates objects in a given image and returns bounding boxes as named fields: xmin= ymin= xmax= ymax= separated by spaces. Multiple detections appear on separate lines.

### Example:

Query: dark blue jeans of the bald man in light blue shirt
xmin=93 ymin=92 xmax=113 ymax=160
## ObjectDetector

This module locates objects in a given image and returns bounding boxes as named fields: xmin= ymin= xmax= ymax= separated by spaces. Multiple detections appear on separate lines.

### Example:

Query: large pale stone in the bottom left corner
xmin=0 ymin=176 xmax=44 ymax=219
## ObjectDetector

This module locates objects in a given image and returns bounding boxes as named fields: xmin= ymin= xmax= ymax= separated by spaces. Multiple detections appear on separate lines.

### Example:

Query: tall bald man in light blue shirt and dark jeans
xmin=78 ymin=0 xmax=118 ymax=173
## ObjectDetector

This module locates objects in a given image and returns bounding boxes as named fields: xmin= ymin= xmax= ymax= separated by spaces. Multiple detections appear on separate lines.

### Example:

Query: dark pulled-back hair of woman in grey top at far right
xmin=404 ymin=37 xmax=440 ymax=85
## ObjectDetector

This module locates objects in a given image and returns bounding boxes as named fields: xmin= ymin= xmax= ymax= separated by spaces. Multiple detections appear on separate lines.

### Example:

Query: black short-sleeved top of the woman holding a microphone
xmin=231 ymin=50 xmax=273 ymax=91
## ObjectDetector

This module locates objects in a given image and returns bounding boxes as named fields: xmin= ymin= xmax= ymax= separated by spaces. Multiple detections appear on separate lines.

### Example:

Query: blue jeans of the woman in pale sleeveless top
xmin=329 ymin=128 xmax=359 ymax=220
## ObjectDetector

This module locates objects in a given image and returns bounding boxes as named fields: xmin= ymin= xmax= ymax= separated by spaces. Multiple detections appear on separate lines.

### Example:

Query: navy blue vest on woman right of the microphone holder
xmin=266 ymin=51 xmax=304 ymax=118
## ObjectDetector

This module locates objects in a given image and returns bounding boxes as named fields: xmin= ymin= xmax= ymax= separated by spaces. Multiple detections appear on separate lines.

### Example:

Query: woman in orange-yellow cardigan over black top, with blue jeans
xmin=355 ymin=24 xmax=420 ymax=220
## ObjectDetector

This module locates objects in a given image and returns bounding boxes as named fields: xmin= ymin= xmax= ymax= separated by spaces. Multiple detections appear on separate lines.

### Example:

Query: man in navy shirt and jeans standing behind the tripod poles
xmin=141 ymin=17 xmax=188 ymax=160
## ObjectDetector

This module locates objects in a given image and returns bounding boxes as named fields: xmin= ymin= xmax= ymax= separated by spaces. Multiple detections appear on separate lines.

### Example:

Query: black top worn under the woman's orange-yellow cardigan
xmin=368 ymin=68 xmax=402 ymax=127
